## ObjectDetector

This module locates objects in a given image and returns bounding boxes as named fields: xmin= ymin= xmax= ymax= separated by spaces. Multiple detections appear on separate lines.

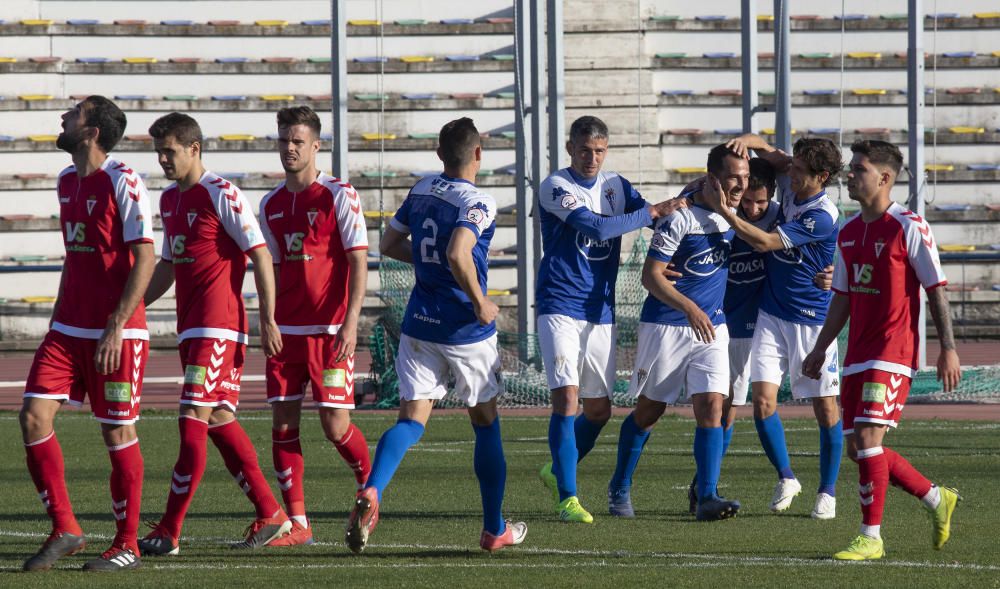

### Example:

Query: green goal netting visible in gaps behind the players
xmin=370 ymin=232 xmax=1000 ymax=408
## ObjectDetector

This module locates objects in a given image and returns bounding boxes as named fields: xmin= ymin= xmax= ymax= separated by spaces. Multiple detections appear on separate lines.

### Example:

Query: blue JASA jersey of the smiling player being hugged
xmin=639 ymin=204 xmax=734 ymax=325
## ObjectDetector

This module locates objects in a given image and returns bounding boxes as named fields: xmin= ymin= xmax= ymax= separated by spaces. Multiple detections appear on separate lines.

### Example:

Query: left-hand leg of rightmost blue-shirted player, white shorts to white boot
xmin=750 ymin=312 xmax=802 ymax=512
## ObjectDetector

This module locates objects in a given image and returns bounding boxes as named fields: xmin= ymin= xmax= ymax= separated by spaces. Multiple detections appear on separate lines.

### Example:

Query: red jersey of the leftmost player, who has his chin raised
xmin=52 ymin=157 xmax=153 ymax=340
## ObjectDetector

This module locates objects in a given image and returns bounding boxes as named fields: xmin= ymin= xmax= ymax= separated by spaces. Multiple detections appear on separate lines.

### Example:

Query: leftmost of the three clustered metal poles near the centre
xmin=514 ymin=0 xmax=537 ymax=346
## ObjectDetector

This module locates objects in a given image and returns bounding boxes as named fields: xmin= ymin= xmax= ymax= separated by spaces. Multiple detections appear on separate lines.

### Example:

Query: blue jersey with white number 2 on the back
xmin=390 ymin=174 xmax=497 ymax=344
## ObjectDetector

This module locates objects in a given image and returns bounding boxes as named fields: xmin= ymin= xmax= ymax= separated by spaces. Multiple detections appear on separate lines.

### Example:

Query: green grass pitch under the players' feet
xmin=0 ymin=411 xmax=1000 ymax=589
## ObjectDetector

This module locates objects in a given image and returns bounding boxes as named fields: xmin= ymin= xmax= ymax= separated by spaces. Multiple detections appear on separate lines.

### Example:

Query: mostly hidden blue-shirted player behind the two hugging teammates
xmin=688 ymin=157 xmax=780 ymax=513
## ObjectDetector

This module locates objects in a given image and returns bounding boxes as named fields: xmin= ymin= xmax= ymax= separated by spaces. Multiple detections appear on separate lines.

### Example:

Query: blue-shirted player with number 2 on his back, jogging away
xmin=347 ymin=118 xmax=527 ymax=553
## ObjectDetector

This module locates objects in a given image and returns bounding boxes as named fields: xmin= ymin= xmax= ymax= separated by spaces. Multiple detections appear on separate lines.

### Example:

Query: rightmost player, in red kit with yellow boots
xmin=802 ymin=140 xmax=961 ymax=560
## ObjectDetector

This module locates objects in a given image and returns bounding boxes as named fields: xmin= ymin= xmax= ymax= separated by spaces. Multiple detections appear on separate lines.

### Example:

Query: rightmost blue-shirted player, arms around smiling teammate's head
xmin=712 ymin=134 xmax=844 ymax=519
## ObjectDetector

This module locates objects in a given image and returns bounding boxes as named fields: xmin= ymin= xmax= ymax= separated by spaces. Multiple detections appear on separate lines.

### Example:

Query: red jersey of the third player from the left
xmin=260 ymin=174 xmax=368 ymax=335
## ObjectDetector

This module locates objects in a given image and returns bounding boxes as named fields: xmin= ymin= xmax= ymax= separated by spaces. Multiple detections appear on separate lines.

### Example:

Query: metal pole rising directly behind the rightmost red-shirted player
xmin=906 ymin=0 xmax=927 ymax=368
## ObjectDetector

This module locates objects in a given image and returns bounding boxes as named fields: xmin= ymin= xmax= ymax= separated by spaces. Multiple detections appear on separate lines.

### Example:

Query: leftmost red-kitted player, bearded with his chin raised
xmin=20 ymin=96 xmax=154 ymax=571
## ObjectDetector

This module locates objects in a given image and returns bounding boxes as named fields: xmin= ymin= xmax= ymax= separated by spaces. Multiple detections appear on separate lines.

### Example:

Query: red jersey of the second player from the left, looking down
xmin=160 ymin=172 xmax=264 ymax=344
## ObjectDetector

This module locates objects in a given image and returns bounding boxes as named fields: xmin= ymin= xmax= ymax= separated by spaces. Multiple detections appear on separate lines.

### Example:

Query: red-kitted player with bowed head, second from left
xmin=139 ymin=113 xmax=292 ymax=555
